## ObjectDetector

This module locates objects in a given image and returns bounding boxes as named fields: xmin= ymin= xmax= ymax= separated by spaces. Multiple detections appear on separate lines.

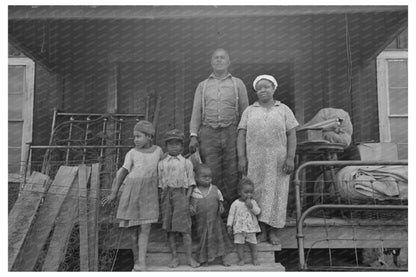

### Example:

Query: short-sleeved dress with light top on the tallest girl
xmin=117 ymin=145 xmax=163 ymax=227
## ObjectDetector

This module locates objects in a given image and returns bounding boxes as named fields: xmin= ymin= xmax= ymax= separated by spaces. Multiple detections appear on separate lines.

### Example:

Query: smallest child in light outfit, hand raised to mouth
xmin=227 ymin=177 xmax=261 ymax=265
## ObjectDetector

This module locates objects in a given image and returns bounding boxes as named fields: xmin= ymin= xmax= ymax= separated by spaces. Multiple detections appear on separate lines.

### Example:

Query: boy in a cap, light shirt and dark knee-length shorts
xmin=158 ymin=129 xmax=199 ymax=268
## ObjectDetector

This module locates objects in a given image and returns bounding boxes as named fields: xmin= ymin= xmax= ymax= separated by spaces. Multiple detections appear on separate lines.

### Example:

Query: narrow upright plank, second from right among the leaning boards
xmin=78 ymin=165 xmax=89 ymax=271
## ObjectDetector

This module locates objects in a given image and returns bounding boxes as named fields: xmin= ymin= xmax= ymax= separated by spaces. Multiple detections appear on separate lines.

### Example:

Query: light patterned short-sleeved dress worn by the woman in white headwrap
xmin=238 ymin=101 xmax=299 ymax=228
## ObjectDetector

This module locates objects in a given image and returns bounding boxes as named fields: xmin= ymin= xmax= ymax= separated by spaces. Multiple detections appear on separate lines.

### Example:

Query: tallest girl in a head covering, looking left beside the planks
xmin=102 ymin=120 xmax=163 ymax=271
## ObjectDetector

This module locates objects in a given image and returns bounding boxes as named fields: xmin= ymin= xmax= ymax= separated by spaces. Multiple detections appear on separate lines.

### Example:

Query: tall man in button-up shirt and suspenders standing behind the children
xmin=189 ymin=48 xmax=248 ymax=207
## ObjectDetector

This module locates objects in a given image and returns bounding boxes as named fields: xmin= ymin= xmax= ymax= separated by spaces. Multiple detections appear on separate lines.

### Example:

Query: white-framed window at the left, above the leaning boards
xmin=8 ymin=57 xmax=35 ymax=182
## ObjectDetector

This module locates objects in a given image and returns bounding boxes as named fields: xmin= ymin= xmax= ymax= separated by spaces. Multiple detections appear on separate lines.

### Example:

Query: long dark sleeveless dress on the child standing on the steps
xmin=191 ymin=185 xmax=233 ymax=263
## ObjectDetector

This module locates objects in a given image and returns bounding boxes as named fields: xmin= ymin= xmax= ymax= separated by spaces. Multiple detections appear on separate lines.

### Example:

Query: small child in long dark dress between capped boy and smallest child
xmin=191 ymin=164 xmax=233 ymax=266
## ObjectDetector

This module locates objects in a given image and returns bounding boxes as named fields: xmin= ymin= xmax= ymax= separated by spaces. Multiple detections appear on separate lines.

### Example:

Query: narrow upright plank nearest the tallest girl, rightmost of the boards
xmin=88 ymin=164 xmax=100 ymax=271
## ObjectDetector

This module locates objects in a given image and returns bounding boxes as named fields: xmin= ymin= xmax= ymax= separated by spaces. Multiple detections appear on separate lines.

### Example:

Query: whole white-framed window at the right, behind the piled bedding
xmin=377 ymin=51 xmax=408 ymax=159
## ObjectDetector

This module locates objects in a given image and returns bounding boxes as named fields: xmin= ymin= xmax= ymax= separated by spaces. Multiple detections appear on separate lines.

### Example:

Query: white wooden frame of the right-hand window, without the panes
xmin=377 ymin=50 xmax=409 ymax=142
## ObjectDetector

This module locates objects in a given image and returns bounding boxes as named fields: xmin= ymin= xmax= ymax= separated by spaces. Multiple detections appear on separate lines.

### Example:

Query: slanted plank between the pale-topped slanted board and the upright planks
xmin=42 ymin=167 xmax=91 ymax=271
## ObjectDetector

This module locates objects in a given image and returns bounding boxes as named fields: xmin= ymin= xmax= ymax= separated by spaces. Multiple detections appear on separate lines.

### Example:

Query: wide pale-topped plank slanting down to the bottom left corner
xmin=13 ymin=166 xmax=78 ymax=271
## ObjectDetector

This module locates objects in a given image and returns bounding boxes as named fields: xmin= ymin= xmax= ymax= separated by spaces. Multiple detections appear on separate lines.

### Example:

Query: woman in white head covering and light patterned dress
xmin=237 ymin=75 xmax=299 ymax=244
